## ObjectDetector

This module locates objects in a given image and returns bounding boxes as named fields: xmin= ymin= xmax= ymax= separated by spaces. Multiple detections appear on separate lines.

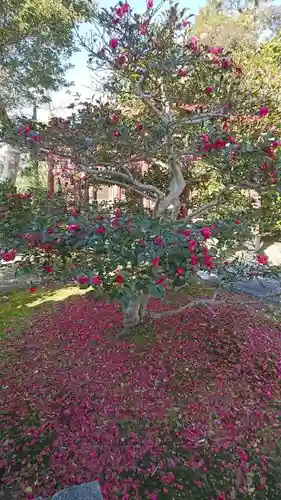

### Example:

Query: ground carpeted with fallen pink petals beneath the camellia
xmin=0 ymin=288 xmax=281 ymax=500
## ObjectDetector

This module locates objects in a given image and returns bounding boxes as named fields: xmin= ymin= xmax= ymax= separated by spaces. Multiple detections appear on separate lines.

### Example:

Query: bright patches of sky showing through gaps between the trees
xmin=35 ymin=0 xmax=205 ymax=120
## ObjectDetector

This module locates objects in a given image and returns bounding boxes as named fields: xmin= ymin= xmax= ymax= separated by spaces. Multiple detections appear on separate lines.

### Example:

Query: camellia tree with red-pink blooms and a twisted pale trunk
xmin=0 ymin=0 xmax=281 ymax=331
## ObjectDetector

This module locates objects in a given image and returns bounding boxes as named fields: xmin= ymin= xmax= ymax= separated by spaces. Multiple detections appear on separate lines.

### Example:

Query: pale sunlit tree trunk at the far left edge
xmin=0 ymin=143 xmax=20 ymax=185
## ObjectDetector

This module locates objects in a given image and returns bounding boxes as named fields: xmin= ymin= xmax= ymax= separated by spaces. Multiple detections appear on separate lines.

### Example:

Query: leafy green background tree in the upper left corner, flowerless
xmin=0 ymin=0 xmax=94 ymax=182
